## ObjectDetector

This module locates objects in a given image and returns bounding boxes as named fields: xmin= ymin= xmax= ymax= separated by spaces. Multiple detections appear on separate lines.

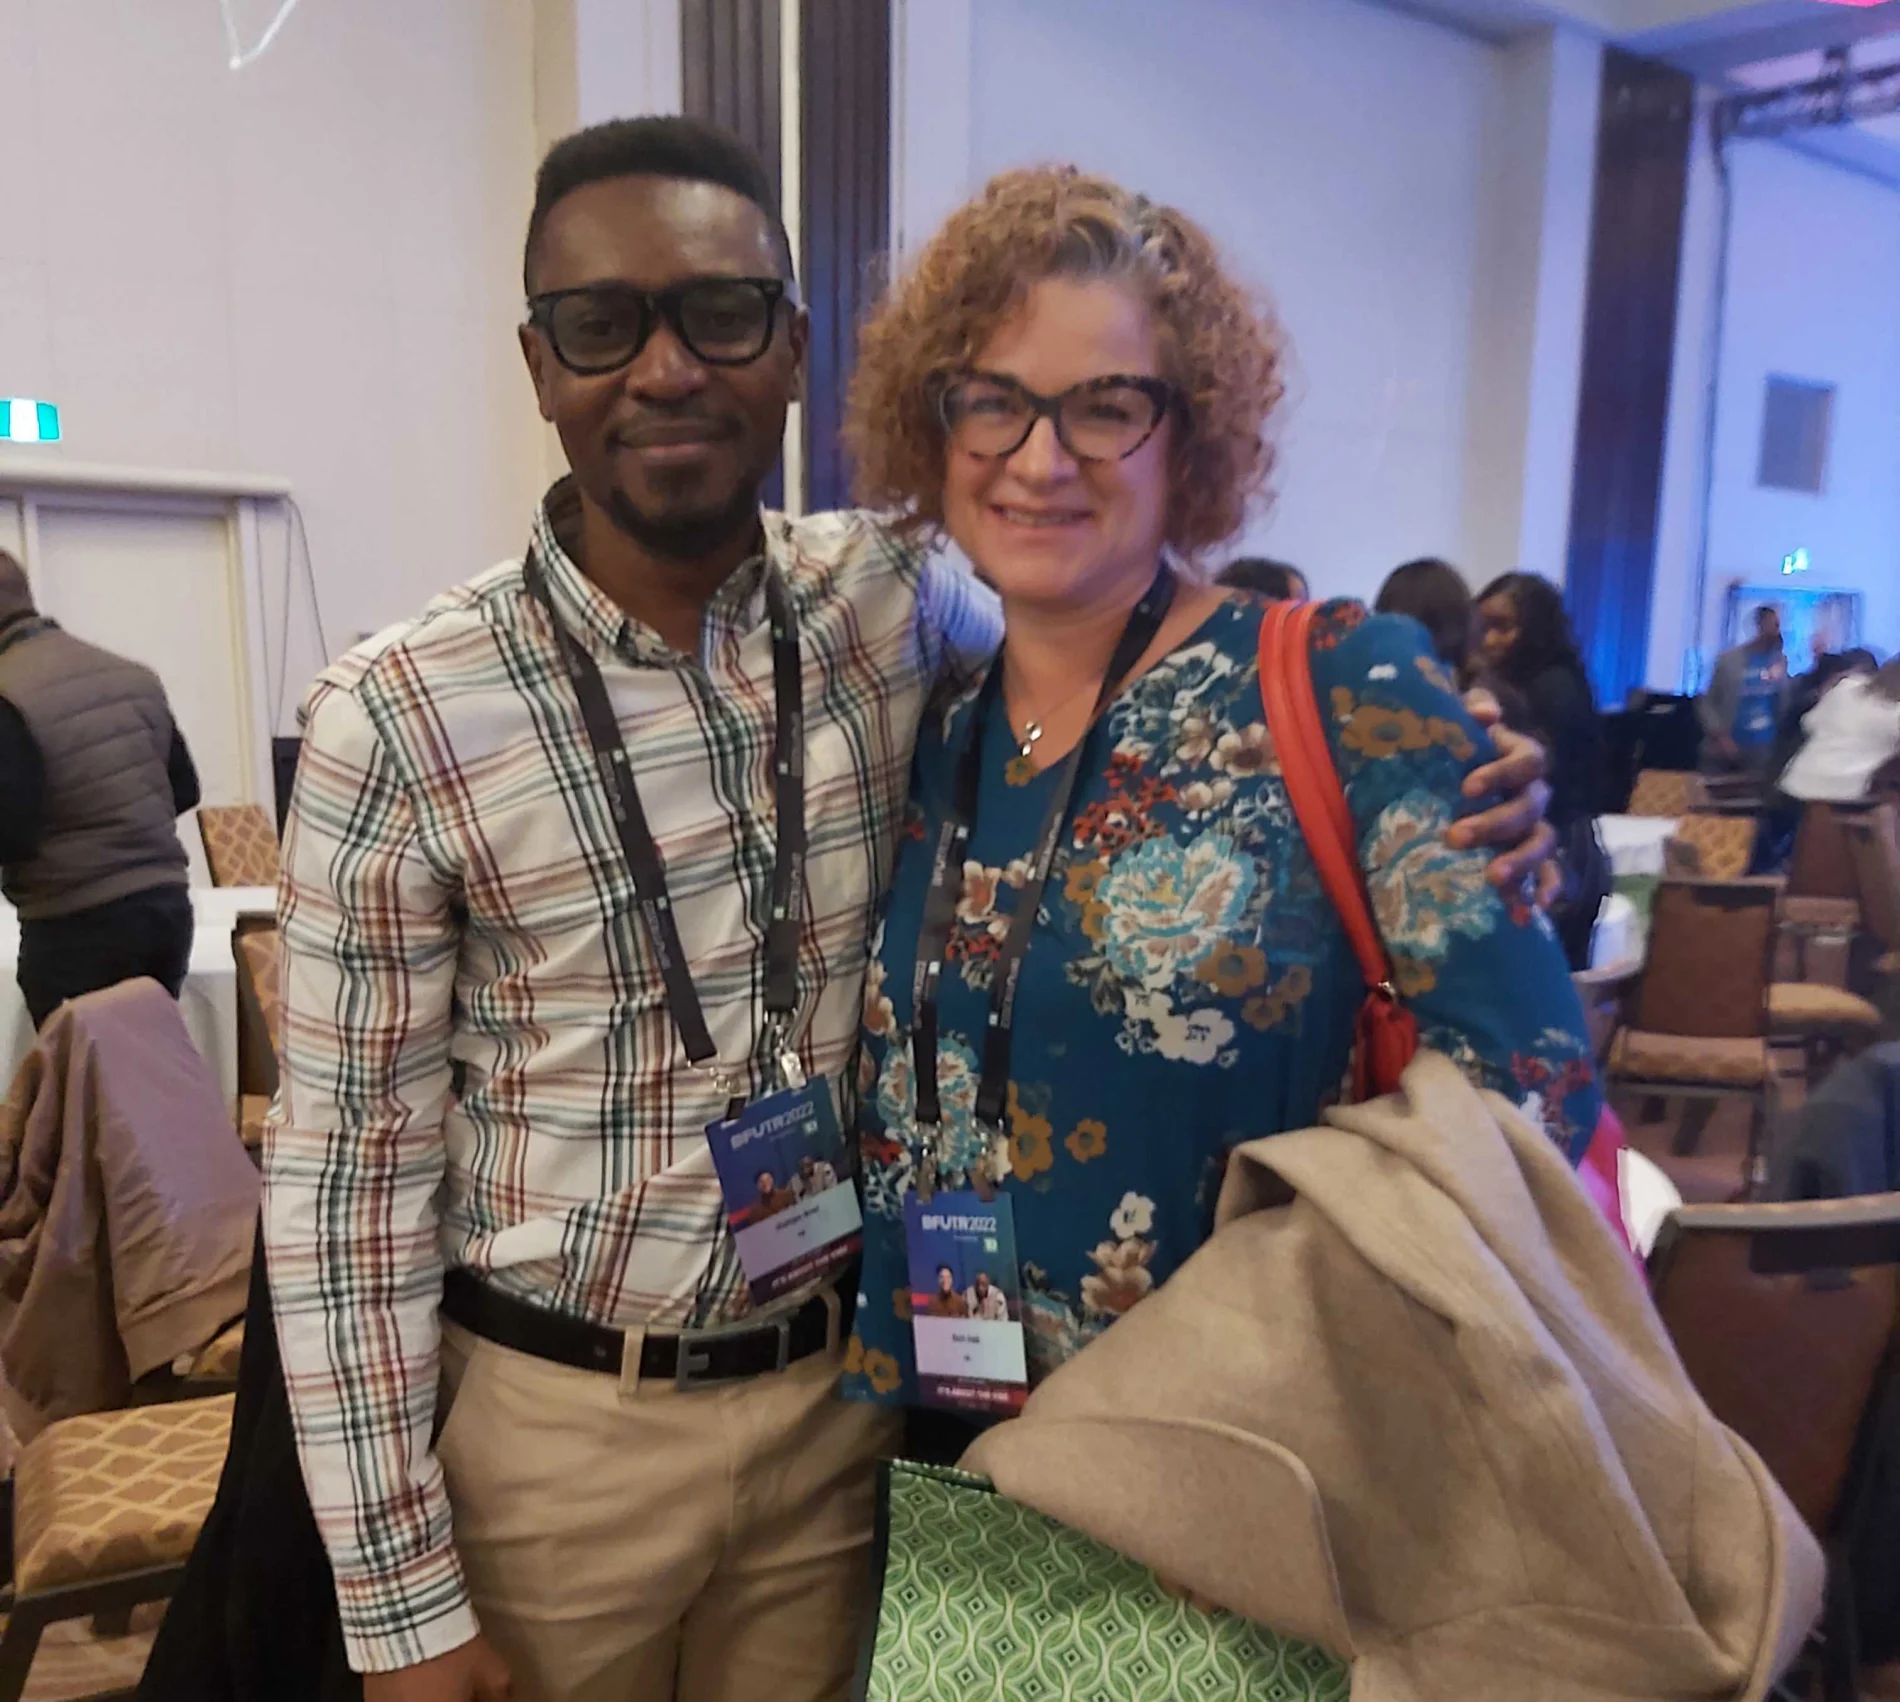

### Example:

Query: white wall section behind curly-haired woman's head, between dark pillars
xmin=897 ymin=0 xmax=1558 ymax=595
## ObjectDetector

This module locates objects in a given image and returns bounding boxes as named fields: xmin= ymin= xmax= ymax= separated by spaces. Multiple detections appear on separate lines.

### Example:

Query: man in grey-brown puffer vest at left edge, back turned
xmin=0 ymin=551 xmax=198 ymax=1028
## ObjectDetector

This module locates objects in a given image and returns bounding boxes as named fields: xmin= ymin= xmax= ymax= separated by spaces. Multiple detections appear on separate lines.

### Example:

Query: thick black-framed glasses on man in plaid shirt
xmin=528 ymin=277 xmax=785 ymax=376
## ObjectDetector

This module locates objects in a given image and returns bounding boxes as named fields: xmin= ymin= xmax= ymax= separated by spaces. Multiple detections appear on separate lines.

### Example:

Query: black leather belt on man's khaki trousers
xmin=443 ymin=1267 xmax=857 ymax=1390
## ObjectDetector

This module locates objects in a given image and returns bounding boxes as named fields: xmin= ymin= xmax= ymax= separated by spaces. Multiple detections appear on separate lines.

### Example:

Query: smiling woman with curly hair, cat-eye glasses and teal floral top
xmin=846 ymin=169 xmax=1598 ymax=1457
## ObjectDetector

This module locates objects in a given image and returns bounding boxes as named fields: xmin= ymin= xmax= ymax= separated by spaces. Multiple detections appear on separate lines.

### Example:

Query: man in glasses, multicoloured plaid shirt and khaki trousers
xmin=266 ymin=118 xmax=1541 ymax=1702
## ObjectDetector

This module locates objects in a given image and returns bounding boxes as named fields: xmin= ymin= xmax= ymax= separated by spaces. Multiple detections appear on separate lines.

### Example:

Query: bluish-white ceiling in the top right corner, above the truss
xmin=1395 ymin=0 xmax=1900 ymax=188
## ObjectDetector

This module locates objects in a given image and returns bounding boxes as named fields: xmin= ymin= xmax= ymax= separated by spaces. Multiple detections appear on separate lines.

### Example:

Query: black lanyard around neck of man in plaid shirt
xmin=523 ymin=547 xmax=806 ymax=1087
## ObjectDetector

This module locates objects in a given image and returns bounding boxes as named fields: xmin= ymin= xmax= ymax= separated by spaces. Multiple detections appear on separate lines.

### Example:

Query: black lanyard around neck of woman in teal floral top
xmin=910 ymin=562 xmax=1174 ymax=1128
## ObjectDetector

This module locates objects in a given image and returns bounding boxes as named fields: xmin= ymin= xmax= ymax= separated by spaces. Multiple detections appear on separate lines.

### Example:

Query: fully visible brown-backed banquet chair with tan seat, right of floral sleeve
xmin=1607 ymin=878 xmax=1784 ymax=1193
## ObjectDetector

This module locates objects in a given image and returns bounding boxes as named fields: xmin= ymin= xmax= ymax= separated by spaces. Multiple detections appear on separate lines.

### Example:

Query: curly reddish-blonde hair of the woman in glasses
xmin=844 ymin=165 xmax=1284 ymax=566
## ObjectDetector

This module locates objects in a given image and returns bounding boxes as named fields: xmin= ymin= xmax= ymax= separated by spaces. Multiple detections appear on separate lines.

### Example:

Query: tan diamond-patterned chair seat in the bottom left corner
xmin=13 ymin=1394 xmax=232 ymax=1598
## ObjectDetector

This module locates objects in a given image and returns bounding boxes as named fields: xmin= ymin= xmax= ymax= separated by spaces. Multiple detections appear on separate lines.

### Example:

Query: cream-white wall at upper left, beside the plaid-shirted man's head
xmin=0 ymin=0 xmax=543 ymax=721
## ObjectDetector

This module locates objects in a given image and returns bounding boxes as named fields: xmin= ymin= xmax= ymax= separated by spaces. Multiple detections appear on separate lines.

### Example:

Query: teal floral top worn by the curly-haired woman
xmin=844 ymin=595 xmax=1598 ymax=1406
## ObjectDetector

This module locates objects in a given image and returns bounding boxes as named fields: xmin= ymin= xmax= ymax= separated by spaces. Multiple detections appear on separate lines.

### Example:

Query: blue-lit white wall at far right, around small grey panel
xmin=1649 ymin=132 xmax=1900 ymax=688
